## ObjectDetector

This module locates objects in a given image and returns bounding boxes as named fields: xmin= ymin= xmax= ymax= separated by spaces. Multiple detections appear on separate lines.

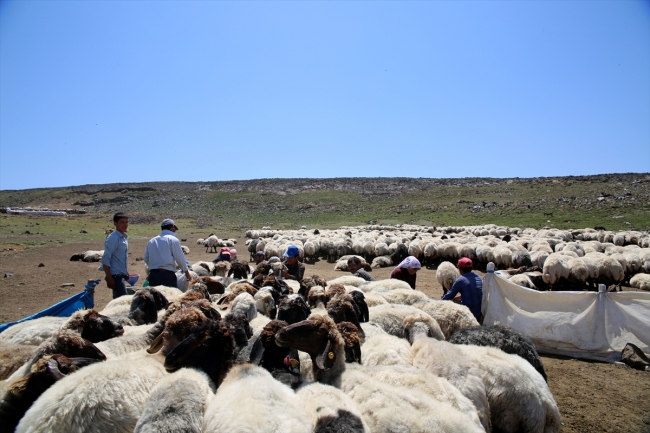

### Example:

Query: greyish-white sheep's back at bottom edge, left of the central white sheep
xmin=133 ymin=368 xmax=215 ymax=433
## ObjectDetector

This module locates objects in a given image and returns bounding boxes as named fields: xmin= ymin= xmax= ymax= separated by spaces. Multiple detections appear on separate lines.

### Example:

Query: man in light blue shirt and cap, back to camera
xmin=144 ymin=218 xmax=192 ymax=287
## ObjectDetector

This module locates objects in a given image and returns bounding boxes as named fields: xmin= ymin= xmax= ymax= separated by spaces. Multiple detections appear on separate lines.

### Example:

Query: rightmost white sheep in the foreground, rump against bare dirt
xmin=455 ymin=345 xmax=561 ymax=433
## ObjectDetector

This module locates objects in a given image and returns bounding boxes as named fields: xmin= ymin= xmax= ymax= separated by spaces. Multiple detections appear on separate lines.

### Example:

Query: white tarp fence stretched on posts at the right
xmin=481 ymin=271 xmax=650 ymax=362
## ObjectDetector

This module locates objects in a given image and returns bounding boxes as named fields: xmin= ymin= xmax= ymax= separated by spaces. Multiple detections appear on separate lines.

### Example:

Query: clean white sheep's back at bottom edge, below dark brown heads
xmin=203 ymin=364 xmax=312 ymax=433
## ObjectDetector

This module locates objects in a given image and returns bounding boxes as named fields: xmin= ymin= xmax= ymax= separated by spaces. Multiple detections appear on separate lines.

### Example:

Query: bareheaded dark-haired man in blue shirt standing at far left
xmin=102 ymin=212 xmax=129 ymax=299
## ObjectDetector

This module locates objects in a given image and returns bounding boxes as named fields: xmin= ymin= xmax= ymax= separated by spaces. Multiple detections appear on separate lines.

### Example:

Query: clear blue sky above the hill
xmin=0 ymin=0 xmax=650 ymax=189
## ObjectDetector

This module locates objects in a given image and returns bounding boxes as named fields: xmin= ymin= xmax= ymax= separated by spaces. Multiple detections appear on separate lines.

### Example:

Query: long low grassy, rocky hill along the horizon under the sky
xmin=0 ymin=173 xmax=650 ymax=230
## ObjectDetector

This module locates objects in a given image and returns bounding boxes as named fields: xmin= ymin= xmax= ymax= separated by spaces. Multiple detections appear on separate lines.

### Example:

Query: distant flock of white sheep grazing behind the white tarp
xmin=240 ymin=224 xmax=650 ymax=291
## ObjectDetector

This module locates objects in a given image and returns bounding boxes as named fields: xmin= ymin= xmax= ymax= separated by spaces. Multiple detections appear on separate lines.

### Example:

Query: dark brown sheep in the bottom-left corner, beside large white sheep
xmin=0 ymin=354 xmax=100 ymax=433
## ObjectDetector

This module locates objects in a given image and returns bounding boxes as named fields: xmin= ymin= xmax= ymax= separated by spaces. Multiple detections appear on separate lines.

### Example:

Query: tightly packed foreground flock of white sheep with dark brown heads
xmin=0 ymin=251 xmax=560 ymax=433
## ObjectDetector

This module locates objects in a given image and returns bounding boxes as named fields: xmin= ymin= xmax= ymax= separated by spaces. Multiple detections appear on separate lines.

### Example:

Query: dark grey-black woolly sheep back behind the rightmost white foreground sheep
xmin=449 ymin=325 xmax=548 ymax=382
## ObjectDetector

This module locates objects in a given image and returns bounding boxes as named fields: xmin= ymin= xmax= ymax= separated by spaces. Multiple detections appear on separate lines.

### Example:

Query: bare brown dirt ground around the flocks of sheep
xmin=0 ymin=233 xmax=650 ymax=433
